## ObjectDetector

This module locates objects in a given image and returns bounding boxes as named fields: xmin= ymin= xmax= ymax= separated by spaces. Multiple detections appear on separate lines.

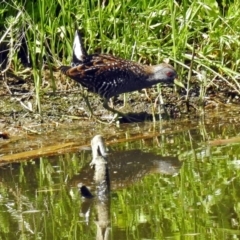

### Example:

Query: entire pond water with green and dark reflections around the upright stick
xmin=0 ymin=115 xmax=240 ymax=240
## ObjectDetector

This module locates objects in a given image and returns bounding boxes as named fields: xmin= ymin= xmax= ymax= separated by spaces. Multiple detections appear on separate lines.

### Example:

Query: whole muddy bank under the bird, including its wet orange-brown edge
xmin=0 ymin=68 xmax=240 ymax=159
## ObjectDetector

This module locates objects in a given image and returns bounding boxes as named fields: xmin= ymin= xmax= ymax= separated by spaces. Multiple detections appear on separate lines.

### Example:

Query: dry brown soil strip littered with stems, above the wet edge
xmin=0 ymin=70 xmax=240 ymax=138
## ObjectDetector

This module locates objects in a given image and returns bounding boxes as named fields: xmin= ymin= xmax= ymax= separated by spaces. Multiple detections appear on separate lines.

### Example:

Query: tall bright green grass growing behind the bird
xmin=0 ymin=0 xmax=240 ymax=111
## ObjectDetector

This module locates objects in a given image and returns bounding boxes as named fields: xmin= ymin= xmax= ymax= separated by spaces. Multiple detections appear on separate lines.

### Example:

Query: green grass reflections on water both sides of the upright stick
xmin=0 ymin=124 xmax=240 ymax=240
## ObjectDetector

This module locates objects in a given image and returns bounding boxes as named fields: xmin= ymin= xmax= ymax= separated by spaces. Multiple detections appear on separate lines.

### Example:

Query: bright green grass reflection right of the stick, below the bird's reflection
xmin=112 ymin=146 xmax=239 ymax=239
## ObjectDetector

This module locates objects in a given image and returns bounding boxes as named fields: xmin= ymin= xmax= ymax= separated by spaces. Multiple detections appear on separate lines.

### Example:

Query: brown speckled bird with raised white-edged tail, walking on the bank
xmin=60 ymin=30 xmax=177 ymax=121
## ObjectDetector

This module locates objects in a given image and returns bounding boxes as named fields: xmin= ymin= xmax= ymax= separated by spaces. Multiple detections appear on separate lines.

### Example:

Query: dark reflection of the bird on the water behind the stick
xmin=70 ymin=150 xmax=182 ymax=190
